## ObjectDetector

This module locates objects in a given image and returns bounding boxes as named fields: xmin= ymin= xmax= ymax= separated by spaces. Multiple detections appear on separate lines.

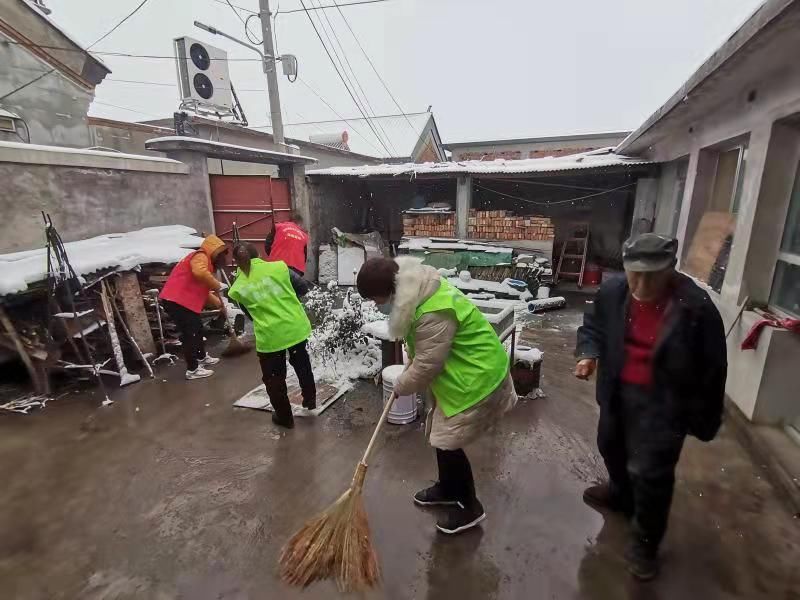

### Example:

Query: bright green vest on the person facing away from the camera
xmin=228 ymin=258 xmax=311 ymax=352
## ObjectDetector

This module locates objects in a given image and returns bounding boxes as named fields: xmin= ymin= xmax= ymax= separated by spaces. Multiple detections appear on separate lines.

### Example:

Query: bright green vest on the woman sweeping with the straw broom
xmin=406 ymin=279 xmax=509 ymax=417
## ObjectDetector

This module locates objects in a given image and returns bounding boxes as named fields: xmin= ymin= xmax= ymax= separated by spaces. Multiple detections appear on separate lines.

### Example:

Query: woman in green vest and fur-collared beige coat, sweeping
xmin=356 ymin=257 xmax=517 ymax=534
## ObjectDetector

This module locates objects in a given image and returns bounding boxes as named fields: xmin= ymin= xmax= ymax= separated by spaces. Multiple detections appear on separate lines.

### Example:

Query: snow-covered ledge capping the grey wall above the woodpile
xmin=0 ymin=142 xmax=189 ymax=174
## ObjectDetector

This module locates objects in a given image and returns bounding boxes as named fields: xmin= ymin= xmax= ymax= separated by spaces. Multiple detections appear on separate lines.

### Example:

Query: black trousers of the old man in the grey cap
xmin=597 ymin=384 xmax=686 ymax=549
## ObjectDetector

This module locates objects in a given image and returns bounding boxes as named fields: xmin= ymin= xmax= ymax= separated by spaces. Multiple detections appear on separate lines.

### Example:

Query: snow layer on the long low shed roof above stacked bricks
xmin=306 ymin=148 xmax=653 ymax=177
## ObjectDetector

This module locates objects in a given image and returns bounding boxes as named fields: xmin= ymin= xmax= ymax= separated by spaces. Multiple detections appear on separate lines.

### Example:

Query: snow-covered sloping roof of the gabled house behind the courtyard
xmin=284 ymin=112 xmax=431 ymax=158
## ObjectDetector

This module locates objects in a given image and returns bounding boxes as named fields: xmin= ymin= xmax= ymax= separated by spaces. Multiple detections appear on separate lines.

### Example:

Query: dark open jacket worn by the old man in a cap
xmin=575 ymin=273 xmax=728 ymax=441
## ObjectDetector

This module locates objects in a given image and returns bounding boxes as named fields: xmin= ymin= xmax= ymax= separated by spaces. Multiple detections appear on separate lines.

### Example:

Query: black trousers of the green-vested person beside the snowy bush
xmin=258 ymin=342 xmax=317 ymax=420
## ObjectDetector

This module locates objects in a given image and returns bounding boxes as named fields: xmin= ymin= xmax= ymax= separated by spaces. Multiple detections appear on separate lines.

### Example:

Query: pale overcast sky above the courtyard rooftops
xmin=47 ymin=0 xmax=761 ymax=142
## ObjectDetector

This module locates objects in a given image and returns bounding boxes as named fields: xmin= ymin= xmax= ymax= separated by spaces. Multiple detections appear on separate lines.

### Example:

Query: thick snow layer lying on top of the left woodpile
xmin=0 ymin=225 xmax=203 ymax=296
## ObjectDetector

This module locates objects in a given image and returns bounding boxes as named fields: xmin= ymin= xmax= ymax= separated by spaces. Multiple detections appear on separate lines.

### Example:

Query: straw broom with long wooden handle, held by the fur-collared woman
xmin=280 ymin=393 xmax=395 ymax=592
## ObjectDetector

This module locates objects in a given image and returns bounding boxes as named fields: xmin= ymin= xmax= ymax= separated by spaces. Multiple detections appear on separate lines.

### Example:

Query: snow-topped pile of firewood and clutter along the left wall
xmin=0 ymin=223 xmax=222 ymax=412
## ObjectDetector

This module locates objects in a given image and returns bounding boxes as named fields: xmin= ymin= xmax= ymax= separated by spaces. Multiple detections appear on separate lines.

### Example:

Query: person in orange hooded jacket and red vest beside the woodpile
xmin=159 ymin=235 xmax=228 ymax=379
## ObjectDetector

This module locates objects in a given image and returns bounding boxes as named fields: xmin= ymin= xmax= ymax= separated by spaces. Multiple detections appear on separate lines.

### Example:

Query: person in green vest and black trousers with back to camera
xmin=228 ymin=244 xmax=317 ymax=429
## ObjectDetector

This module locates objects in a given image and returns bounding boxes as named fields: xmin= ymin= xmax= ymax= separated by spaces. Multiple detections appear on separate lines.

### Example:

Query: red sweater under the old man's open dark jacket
xmin=621 ymin=298 xmax=667 ymax=385
